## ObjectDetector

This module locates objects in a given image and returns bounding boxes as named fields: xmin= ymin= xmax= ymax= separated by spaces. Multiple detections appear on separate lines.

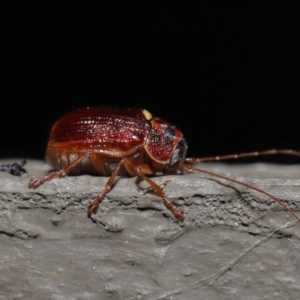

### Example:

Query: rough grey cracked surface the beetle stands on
xmin=0 ymin=159 xmax=300 ymax=300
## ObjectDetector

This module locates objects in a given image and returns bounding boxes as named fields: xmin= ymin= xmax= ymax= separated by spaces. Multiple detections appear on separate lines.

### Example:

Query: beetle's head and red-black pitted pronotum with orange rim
xmin=145 ymin=118 xmax=187 ymax=173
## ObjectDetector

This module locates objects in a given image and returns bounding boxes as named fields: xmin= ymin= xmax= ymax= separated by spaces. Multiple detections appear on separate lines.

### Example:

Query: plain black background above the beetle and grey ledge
xmin=0 ymin=1 xmax=300 ymax=162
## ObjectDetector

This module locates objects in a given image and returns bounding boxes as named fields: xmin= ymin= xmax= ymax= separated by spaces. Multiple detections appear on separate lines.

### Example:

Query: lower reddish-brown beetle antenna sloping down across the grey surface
xmin=182 ymin=164 xmax=300 ymax=223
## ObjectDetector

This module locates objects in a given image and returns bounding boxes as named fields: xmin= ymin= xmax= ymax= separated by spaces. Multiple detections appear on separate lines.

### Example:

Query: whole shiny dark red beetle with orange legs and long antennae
xmin=28 ymin=107 xmax=300 ymax=222
